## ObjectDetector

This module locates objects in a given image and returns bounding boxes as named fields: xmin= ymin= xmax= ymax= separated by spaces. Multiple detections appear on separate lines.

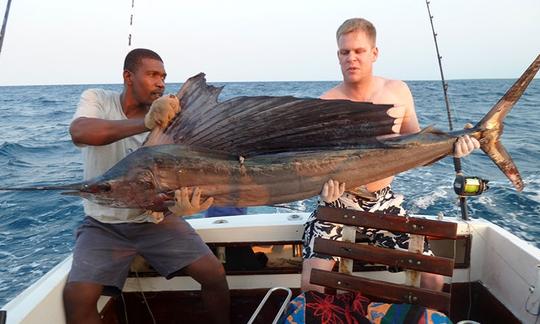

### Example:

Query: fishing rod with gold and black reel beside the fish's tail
xmin=426 ymin=0 xmax=488 ymax=220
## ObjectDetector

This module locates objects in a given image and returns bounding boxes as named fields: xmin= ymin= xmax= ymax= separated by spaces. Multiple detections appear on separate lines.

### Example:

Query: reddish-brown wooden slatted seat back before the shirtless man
xmin=310 ymin=207 xmax=457 ymax=313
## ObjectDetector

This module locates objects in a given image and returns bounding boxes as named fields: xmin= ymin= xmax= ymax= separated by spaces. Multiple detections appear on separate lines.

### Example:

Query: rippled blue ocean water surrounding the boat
xmin=0 ymin=80 xmax=540 ymax=305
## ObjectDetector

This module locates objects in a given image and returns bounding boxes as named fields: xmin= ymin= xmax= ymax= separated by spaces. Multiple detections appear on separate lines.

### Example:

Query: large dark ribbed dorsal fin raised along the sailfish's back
xmin=145 ymin=73 xmax=395 ymax=156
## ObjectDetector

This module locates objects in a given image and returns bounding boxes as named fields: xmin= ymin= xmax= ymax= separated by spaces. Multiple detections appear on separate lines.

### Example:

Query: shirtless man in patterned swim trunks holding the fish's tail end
xmin=301 ymin=18 xmax=480 ymax=292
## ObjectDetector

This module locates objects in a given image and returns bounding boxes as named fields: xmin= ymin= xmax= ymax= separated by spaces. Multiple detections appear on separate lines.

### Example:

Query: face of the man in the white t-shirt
xmin=128 ymin=58 xmax=167 ymax=106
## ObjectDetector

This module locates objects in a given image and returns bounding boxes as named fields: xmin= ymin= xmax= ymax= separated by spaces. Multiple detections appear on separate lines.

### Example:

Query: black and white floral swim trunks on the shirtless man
xmin=302 ymin=187 xmax=432 ymax=261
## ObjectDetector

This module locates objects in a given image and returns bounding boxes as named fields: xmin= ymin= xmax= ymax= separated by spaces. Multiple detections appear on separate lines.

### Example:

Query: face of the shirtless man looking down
xmin=338 ymin=31 xmax=379 ymax=83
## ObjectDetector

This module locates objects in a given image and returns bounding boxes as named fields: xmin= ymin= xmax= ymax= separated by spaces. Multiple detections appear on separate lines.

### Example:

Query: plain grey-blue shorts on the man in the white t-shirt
xmin=67 ymin=215 xmax=212 ymax=290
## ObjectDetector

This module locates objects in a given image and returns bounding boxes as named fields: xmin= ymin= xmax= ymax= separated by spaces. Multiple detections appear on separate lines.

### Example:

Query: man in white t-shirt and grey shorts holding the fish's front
xmin=64 ymin=49 xmax=229 ymax=323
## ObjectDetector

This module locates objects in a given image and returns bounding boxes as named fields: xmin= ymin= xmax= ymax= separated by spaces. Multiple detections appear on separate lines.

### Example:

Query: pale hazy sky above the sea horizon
xmin=0 ymin=0 xmax=540 ymax=86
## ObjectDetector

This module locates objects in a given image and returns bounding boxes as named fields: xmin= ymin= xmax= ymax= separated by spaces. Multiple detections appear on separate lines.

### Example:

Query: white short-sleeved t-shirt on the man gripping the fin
xmin=73 ymin=89 xmax=154 ymax=223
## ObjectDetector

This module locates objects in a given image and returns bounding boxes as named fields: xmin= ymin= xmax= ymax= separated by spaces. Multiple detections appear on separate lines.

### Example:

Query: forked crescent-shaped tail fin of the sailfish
xmin=474 ymin=55 xmax=540 ymax=191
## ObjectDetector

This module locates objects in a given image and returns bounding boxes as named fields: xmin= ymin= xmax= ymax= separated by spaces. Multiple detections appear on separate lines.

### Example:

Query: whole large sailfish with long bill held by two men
xmin=1 ymin=55 xmax=540 ymax=211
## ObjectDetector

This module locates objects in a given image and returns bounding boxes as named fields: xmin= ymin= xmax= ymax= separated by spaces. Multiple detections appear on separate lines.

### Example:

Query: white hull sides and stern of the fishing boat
xmin=3 ymin=213 xmax=540 ymax=324
